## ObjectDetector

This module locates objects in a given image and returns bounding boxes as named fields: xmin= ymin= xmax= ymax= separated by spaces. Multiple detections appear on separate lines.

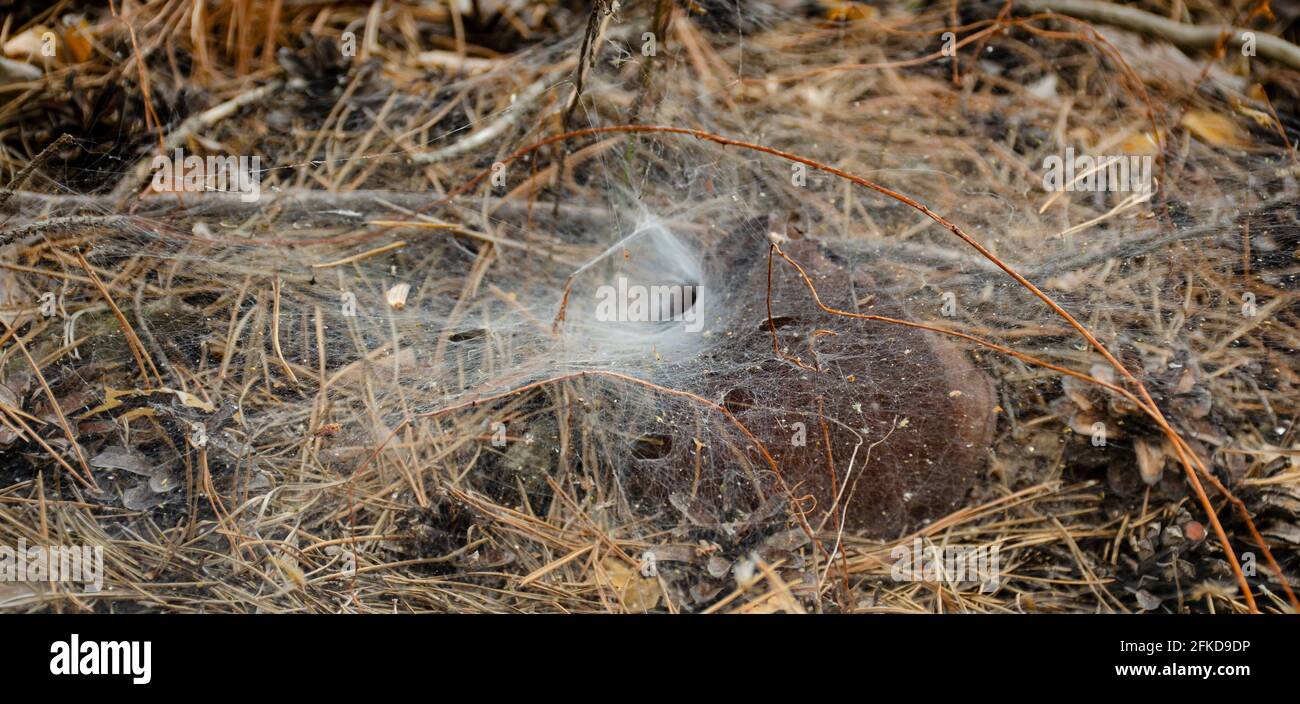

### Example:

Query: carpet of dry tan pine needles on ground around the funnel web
xmin=0 ymin=0 xmax=1300 ymax=613
